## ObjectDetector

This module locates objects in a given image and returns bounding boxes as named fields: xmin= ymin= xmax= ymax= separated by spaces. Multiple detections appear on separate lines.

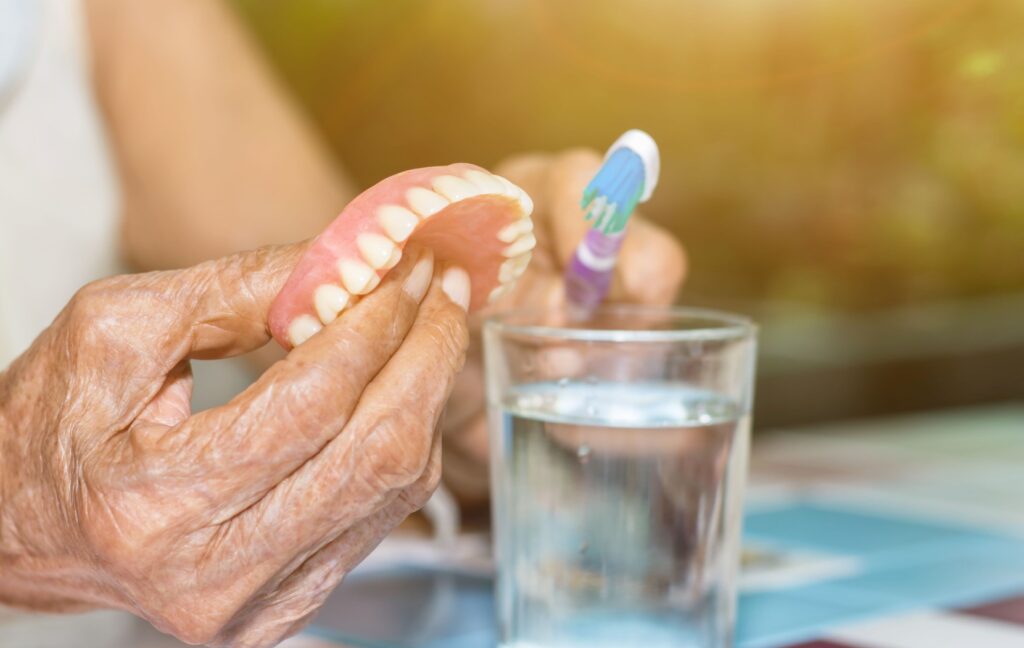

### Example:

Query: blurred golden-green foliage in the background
xmin=234 ymin=0 xmax=1024 ymax=311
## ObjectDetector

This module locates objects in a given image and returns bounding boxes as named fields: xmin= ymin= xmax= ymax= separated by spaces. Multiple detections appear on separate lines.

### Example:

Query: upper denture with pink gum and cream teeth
xmin=269 ymin=163 xmax=537 ymax=349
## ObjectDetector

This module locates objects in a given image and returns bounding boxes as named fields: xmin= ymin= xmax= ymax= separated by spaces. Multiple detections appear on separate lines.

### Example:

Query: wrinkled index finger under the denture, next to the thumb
xmin=168 ymin=249 xmax=433 ymax=505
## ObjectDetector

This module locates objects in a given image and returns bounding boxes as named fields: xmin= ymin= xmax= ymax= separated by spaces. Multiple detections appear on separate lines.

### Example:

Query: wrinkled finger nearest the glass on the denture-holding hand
xmin=237 ymin=268 xmax=469 ymax=551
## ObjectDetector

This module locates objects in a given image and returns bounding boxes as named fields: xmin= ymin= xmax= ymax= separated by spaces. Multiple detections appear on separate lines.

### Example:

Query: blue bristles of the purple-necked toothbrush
xmin=581 ymin=148 xmax=644 ymax=234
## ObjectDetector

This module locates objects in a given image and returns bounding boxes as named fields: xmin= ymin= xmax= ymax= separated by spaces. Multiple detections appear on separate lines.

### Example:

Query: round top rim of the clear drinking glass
xmin=483 ymin=304 xmax=758 ymax=342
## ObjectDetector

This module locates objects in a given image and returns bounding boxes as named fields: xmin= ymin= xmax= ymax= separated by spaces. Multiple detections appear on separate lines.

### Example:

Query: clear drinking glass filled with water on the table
xmin=483 ymin=306 xmax=756 ymax=648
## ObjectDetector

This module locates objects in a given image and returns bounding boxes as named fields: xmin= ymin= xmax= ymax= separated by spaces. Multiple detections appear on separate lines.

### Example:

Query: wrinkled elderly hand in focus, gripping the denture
xmin=0 ymin=247 xmax=469 ymax=646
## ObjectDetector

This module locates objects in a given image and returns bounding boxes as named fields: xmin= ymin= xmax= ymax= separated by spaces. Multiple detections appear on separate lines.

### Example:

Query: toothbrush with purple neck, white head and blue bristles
xmin=565 ymin=129 xmax=660 ymax=313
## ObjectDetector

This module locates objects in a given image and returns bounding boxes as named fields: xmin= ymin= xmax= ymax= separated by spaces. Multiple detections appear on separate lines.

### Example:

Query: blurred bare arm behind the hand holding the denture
xmin=87 ymin=0 xmax=354 ymax=269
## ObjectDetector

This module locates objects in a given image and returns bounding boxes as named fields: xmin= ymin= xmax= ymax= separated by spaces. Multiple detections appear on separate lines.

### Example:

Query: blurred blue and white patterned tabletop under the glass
xmin=0 ymin=402 xmax=1024 ymax=648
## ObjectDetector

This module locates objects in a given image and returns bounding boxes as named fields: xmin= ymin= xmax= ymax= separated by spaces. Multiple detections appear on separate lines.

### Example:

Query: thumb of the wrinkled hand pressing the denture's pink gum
xmin=37 ymin=244 xmax=307 ymax=423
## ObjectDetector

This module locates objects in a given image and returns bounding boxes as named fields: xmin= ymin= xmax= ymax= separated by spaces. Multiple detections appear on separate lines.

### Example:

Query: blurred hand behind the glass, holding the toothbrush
xmin=444 ymin=149 xmax=686 ymax=504
